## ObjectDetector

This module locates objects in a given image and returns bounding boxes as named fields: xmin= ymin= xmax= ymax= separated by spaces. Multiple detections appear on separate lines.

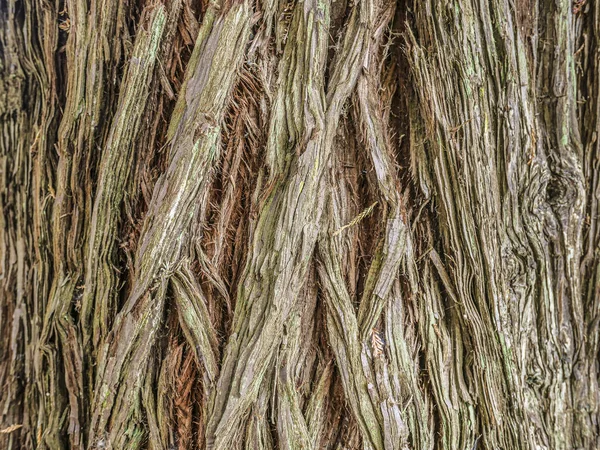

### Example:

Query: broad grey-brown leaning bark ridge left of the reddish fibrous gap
xmin=90 ymin=3 xmax=250 ymax=448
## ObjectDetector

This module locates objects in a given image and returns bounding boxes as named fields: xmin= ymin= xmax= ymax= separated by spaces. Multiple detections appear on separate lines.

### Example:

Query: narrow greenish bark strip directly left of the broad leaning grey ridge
xmin=81 ymin=5 xmax=167 ymax=356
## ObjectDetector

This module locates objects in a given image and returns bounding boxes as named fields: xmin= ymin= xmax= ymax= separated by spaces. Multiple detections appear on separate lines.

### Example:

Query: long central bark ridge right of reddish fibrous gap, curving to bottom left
xmin=207 ymin=1 xmax=333 ymax=442
